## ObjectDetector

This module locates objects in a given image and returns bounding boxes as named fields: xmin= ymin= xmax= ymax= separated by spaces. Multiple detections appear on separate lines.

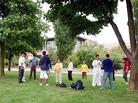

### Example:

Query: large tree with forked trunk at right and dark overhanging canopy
xmin=43 ymin=0 xmax=138 ymax=91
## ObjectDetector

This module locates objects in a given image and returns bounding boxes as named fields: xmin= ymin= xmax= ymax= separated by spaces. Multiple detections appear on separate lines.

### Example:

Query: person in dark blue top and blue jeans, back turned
xmin=101 ymin=54 xmax=113 ymax=90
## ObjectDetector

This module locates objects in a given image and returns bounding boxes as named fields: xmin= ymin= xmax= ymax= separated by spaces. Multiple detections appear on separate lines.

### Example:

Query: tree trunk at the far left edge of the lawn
xmin=0 ymin=42 xmax=4 ymax=76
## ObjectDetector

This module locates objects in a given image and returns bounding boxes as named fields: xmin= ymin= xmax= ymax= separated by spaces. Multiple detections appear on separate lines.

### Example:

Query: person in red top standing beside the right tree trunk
xmin=123 ymin=58 xmax=130 ymax=83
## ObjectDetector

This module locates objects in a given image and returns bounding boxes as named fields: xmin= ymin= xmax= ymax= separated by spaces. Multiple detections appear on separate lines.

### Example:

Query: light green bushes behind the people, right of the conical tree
xmin=66 ymin=42 xmax=123 ymax=70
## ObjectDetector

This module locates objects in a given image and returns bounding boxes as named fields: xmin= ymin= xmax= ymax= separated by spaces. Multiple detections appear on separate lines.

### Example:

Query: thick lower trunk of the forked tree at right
xmin=128 ymin=57 xmax=138 ymax=92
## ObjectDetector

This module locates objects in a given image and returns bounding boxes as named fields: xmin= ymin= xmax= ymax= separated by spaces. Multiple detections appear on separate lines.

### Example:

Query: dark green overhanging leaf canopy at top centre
xmin=43 ymin=0 xmax=118 ymax=36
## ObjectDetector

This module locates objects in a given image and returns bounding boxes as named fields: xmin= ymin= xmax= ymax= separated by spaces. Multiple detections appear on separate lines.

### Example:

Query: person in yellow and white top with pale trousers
xmin=54 ymin=59 xmax=63 ymax=84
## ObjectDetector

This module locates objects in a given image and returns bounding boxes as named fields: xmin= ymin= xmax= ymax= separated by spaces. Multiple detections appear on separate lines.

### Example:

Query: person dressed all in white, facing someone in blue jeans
xmin=92 ymin=55 xmax=102 ymax=87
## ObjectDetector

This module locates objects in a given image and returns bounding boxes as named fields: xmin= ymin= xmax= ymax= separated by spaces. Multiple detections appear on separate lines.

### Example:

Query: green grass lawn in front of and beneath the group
xmin=0 ymin=72 xmax=138 ymax=103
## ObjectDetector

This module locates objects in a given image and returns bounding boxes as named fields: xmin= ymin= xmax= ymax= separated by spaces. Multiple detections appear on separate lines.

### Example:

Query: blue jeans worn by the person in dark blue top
xmin=101 ymin=72 xmax=113 ymax=89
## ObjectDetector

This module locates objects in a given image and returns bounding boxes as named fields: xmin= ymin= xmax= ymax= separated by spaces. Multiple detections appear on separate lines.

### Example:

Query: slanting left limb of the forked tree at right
xmin=110 ymin=20 xmax=132 ymax=59
